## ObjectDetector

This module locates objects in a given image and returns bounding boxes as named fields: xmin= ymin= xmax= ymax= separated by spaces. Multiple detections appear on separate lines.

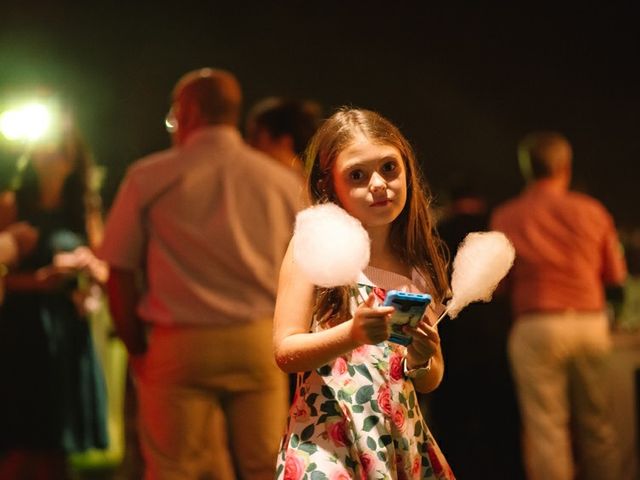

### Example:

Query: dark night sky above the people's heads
xmin=0 ymin=0 xmax=640 ymax=225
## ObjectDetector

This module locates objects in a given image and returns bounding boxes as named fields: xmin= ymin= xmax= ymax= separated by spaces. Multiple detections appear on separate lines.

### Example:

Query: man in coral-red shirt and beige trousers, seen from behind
xmin=491 ymin=132 xmax=626 ymax=480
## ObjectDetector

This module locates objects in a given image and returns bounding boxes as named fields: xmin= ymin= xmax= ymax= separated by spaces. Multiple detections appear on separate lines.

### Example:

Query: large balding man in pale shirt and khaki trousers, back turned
xmin=102 ymin=68 xmax=302 ymax=480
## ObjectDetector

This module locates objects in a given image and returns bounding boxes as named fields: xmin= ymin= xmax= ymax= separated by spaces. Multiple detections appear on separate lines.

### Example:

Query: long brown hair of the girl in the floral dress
xmin=305 ymin=107 xmax=449 ymax=321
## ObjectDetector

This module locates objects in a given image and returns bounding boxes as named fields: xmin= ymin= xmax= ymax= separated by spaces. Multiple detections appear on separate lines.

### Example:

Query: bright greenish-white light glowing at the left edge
xmin=0 ymin=102 xmax=52 ymax=142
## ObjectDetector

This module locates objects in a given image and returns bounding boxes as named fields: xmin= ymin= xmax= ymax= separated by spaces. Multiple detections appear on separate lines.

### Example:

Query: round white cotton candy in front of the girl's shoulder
xmin=293 ymin=203 xmax=371 ymax=287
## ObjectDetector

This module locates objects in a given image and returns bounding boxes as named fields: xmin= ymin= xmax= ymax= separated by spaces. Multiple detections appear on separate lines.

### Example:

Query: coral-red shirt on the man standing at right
xmin=491 ymin=182 xmax=625 ymax=314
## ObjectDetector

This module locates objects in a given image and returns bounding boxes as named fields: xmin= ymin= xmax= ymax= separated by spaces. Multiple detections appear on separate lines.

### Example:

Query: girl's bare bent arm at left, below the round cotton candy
xmin=273 ymin=244 xmax=393 ymax=373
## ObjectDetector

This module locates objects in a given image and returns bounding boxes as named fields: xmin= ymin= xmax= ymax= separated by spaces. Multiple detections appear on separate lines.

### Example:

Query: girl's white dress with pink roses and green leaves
xmin=276 ymin=267 xmax=455 ymax=480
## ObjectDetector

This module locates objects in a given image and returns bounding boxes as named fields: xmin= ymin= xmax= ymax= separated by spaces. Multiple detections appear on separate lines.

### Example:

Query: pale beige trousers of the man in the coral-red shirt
xmin=509 ymin=312 xmax=619 ymax=480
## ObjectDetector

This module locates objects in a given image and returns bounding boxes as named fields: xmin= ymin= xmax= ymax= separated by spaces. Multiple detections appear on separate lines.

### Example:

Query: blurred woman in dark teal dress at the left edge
xmin=0 ymin=109 xmax=107 ymax=479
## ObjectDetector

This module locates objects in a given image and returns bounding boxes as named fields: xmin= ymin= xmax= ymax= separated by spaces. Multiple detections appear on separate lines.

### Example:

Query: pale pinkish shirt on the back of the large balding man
xmin=107 ymin=126 xmax=302 ymax=325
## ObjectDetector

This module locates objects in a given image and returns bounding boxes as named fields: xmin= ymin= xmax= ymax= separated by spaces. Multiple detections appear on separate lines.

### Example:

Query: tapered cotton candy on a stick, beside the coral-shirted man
xmin=447 ymin=232 xmax=516 ymax=318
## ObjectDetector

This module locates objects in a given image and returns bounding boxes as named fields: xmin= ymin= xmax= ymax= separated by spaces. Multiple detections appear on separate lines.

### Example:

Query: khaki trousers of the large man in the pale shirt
xmin=133 ymin=319 xmax=288 ymax=480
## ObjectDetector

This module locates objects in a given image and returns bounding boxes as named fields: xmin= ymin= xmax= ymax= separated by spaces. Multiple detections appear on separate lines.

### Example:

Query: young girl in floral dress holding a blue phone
xmin=274 ymin=109 xmax=454 ymax=480
